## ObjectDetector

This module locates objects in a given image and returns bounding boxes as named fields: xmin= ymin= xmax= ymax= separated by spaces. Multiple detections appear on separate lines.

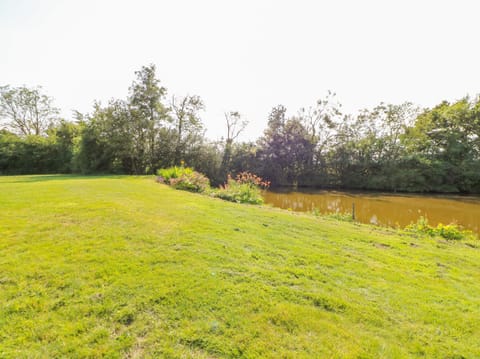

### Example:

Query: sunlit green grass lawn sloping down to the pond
xmin=0 ymin=176 xmax=480 ymax=358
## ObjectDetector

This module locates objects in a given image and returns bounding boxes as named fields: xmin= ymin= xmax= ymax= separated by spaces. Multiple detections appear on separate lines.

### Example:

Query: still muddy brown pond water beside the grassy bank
xmin=264 ymin=190 xmax=480 ymax=235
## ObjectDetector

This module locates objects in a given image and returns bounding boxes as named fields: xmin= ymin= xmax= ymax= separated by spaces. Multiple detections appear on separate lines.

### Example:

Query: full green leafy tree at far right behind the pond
xmin=404 ymin=98 xmax=480 ymax=192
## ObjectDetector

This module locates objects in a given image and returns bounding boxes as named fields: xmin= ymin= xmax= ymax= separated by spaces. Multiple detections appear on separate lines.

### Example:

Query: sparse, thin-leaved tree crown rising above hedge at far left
xmin=0 ymin=86 xmax=60 ymax=136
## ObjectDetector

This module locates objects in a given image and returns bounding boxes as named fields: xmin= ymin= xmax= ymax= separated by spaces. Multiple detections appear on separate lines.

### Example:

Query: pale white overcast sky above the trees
xmin=0 ymin=0 xmax=480 ymax=139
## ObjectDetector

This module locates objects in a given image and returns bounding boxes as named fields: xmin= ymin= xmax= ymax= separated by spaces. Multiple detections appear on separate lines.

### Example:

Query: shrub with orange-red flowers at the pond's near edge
xmin=214 ymin=172 xmax=270 ymax=204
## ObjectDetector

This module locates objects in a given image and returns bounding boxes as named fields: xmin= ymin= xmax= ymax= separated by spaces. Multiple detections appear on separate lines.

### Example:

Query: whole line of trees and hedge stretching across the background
xmin=0 ymin=65 xmax=480 ymax=193
